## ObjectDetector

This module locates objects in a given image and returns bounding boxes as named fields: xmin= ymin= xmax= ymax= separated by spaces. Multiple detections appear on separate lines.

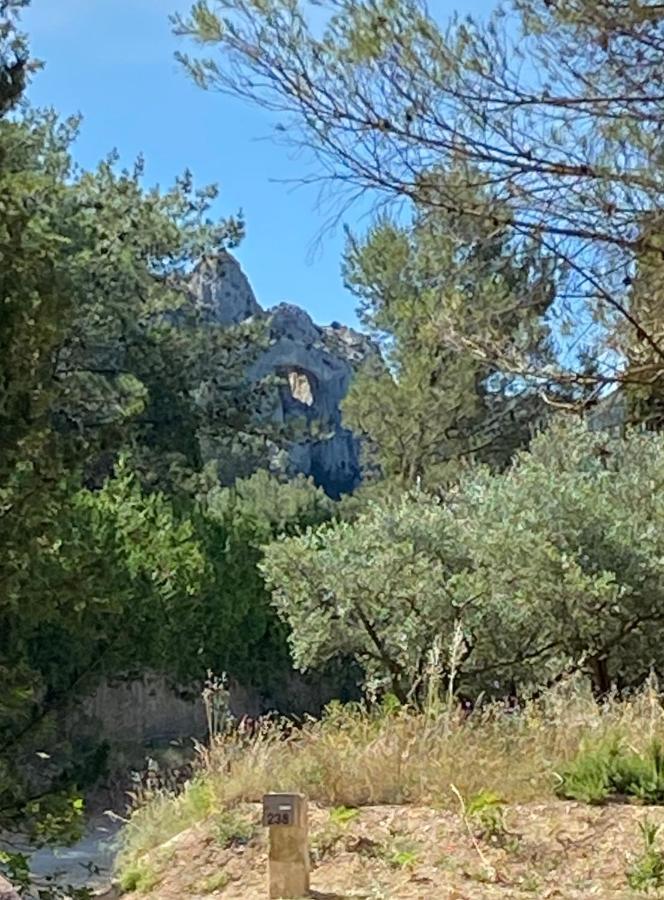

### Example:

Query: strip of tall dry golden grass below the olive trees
xmin=115 ymin=681 xmax=664 ymax=859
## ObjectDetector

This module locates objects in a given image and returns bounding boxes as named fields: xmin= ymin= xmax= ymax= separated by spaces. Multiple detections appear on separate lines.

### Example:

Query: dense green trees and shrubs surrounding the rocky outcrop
xmin=0 ymin=0 xmax=664 ymax=888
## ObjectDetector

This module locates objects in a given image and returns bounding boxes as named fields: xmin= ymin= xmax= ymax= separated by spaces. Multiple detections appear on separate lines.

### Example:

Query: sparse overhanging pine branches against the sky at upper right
xmin=174 ymin=0 xmax=664 ymax=396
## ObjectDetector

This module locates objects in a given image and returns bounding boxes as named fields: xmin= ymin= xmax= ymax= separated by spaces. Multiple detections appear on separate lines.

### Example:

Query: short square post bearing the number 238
xmin=263 ymin=794 xmax=309 ymax=900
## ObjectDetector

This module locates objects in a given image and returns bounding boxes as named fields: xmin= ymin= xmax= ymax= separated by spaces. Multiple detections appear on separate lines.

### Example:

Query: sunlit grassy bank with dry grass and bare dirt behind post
xmin=117 ymin=688 xmax=664 ymax=900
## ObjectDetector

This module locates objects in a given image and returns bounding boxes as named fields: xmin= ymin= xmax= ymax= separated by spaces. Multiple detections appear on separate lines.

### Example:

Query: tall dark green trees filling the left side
xmin=0 ymin=0 xmax=284 ymax=856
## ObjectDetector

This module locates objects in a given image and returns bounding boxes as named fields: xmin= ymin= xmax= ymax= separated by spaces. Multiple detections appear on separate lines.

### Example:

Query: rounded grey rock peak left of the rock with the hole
xmin=189 ymin=250 xmax=263 ymax=325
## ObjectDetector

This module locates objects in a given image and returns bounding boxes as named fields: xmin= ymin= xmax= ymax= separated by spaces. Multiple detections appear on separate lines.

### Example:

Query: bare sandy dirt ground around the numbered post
xmin=125 ymin=802 xmax=664 ymax=900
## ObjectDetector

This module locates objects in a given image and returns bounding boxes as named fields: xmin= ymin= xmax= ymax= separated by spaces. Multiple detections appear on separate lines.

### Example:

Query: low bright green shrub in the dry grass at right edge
xmin=558 ymin=738 xmax=664 ymax=805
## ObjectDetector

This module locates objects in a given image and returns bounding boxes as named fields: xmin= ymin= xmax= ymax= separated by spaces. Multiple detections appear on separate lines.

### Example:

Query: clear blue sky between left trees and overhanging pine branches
xmin=23 ymin=0 xmax=494 ymax=324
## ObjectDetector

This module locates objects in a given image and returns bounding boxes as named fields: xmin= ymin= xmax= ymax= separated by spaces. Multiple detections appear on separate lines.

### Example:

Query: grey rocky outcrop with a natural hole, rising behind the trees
xmin=190 ymin=252 xmax=378 ymax=498
